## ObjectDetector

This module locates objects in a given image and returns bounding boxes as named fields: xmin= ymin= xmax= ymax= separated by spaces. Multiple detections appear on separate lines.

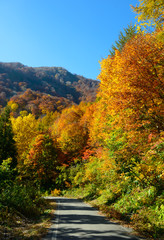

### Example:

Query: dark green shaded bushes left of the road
xmin=0 ymin=159 xmax=44 ymax=222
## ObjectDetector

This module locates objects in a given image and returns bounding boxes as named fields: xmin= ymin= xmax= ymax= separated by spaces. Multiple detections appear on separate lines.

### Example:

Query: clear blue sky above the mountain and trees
xmin=0 ymin=0 xmax=139 ymax=79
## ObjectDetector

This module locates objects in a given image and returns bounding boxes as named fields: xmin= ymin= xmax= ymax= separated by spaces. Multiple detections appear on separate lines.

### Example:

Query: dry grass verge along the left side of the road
xmin=0 ymin=199 xmax=56 ymax=240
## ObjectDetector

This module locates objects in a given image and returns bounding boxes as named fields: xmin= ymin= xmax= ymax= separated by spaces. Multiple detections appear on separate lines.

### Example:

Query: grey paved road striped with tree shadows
xmin=43 ymin=198 xmax=140 ymax=240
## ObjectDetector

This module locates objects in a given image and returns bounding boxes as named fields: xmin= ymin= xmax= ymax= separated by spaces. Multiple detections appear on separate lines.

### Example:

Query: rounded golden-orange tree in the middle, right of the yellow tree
xmin=52 ymin=103 xmax=88 ymax=153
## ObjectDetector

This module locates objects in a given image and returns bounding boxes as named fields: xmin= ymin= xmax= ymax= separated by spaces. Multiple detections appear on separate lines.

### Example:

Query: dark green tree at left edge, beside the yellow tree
xmin=0 ymin=107 xmax=17 ymax=168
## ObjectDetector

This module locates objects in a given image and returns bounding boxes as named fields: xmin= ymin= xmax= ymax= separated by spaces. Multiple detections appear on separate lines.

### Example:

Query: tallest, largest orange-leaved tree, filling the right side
xmin=89 ymin=34 xmax=164 ymax=182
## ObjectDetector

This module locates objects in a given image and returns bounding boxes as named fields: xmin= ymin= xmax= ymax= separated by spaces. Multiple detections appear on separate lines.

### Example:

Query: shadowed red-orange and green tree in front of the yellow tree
xmin=20 ymin=134 xmax=59 ymax=189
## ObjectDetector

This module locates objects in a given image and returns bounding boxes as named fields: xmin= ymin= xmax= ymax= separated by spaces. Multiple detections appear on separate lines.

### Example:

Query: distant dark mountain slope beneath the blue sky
xmin=0 ymin=62 xmax=99 ymax=105
